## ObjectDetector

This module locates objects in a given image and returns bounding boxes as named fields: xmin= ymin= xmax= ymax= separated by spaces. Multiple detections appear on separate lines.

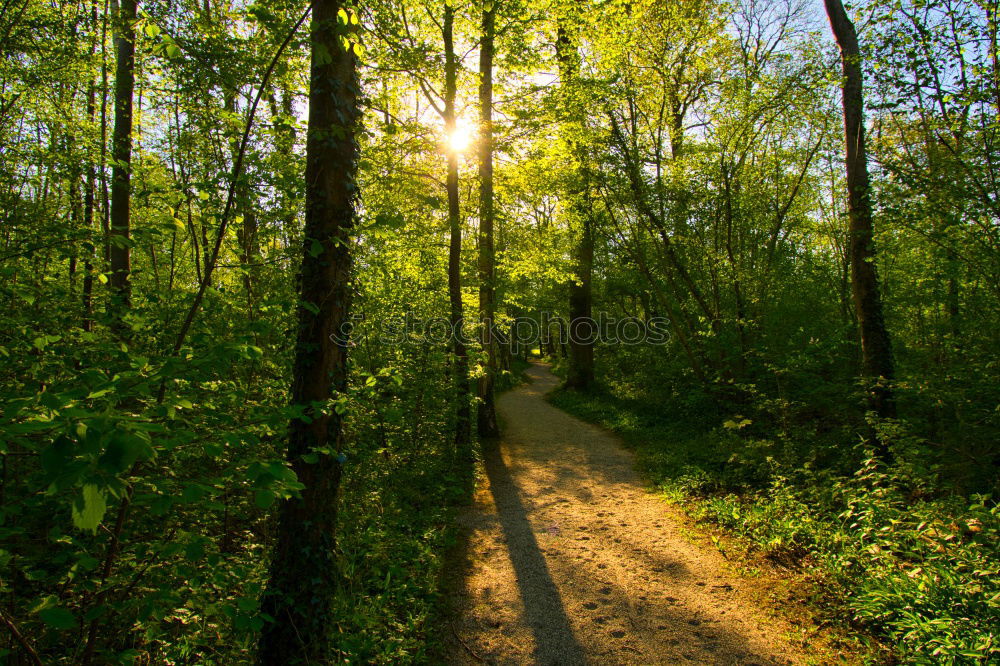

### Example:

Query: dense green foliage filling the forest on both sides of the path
xmin=0 ymin=0 xmax=1000 ymax=664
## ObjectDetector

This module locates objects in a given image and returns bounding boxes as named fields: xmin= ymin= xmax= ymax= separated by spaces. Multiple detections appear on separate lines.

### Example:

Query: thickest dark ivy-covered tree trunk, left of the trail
xmin=258 ymin=0 xmax=360 ymax=652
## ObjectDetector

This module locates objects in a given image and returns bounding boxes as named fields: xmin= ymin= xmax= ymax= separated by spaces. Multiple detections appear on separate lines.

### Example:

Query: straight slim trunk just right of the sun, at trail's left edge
xmin=477 ymin=5 xmax=500 ymax=438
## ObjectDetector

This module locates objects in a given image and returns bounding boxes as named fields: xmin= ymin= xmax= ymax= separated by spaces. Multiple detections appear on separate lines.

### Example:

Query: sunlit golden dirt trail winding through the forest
xmin=448 ymin=365 xmax=815 ymax=664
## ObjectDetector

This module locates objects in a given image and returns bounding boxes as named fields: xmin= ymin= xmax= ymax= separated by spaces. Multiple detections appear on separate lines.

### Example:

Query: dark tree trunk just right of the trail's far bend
xmin=556 ymin=25 xmax=596 ymax=390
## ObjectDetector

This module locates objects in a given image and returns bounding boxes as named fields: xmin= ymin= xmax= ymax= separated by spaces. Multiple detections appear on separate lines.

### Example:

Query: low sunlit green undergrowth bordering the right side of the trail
xmin=550 ymin=364 xmax=1000 ymax=663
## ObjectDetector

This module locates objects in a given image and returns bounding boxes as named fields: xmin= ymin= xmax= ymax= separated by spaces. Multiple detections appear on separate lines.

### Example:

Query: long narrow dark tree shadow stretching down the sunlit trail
xmin=483 ymin=442 xmax=587 ymax=664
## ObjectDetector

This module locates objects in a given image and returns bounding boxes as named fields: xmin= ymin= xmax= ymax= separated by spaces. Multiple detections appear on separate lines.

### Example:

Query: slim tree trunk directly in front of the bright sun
xmin=442 ymin=3 xmax=472 ymax=457
